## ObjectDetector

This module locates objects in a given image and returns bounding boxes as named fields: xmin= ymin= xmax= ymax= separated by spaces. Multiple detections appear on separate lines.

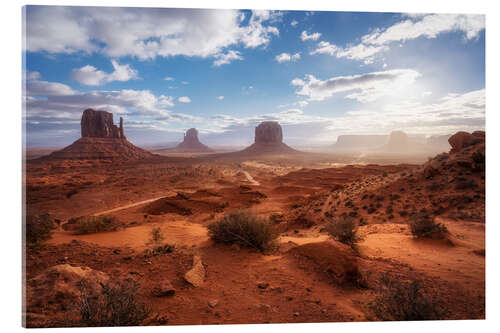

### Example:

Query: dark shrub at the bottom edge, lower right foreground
xmin=370 ymin=274 xmax=446 ymax=321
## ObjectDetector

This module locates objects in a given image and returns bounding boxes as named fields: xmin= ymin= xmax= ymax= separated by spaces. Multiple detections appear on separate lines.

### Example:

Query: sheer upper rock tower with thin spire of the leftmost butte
xmin=81 ymin=109 xmax=125 ymax=139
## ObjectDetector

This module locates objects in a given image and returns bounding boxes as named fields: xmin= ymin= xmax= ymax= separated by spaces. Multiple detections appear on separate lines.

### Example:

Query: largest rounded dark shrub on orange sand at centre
xmin=208 ymin=211 xmax=278 ymax=251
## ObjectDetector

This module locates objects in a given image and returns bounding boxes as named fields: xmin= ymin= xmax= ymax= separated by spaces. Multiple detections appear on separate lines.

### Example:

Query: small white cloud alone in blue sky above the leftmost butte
xmin=71 ymin=60 xmax=138 ymax=86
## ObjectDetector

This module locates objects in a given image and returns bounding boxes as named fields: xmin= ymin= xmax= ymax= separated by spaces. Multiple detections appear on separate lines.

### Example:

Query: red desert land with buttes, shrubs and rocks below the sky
xmin=23 ymin=109 xmax=485 ymax=327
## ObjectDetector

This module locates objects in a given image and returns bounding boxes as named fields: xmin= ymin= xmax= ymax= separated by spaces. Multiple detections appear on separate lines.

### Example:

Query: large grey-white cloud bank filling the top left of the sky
xmin=26 ymin=6 xmax=280 ymax=60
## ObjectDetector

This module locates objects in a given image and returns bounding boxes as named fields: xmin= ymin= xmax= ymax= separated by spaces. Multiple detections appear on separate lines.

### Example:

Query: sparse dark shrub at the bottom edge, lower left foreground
xmin=80 ymin=279 xmax=150 ymax=327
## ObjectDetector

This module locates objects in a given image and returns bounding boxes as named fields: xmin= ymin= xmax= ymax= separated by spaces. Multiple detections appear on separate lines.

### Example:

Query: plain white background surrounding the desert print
xmin=0 ymin=0 xmax=500 ymax=333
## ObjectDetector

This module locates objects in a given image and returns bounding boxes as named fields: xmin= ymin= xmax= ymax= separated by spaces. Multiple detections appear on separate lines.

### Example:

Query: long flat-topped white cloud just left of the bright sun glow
xmin=291 ymin=69 xmax=420 ymax=102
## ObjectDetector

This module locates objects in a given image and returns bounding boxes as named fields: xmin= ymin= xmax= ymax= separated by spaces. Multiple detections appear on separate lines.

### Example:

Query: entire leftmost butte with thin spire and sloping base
xmin=48 ymin=109 xmax=154 ymax=160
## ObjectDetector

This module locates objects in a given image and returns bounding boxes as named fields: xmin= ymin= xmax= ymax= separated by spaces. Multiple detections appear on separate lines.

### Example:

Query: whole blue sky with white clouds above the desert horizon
xmin=22 ymin=6 xmax=485 ymax=147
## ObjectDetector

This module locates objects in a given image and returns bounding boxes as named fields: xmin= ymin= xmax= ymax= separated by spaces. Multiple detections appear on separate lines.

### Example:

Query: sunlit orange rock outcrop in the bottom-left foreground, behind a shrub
xmin=26 ymin=264 xmax=109 ymax=310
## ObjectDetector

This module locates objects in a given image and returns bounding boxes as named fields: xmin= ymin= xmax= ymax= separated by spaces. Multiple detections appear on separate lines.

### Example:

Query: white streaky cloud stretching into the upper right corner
xmin=310 ymin=14 xmax=485 ymax=64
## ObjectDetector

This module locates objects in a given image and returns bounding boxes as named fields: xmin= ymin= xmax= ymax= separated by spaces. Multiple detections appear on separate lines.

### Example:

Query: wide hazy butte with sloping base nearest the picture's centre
xmin=239 ymin=121 xmax=298 ymax=155
